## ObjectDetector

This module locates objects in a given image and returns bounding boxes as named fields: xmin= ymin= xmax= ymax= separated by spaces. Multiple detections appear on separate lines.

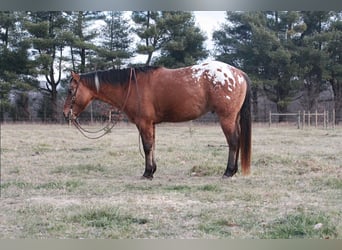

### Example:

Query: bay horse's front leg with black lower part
xmin=138 ymin=123 xmax=157 ymax=179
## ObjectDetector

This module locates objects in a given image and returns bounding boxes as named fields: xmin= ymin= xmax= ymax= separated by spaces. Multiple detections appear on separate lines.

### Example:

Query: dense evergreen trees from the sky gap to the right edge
xmin=213 ymin=11 xmax=342 ymax=121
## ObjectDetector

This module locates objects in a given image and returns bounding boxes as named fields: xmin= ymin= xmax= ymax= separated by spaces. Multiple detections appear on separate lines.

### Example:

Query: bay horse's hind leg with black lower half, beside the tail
xmin=220 ymin=117 xmax=240 ymax=177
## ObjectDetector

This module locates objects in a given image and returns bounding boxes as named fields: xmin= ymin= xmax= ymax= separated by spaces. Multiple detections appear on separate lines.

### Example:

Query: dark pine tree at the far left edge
xmin=0 ymin=11 xmax=38 ymax=121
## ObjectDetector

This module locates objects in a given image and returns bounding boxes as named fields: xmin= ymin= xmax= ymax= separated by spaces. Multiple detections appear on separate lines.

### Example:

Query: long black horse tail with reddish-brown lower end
xmin=240 ymin=75 xmax=252 ymax=175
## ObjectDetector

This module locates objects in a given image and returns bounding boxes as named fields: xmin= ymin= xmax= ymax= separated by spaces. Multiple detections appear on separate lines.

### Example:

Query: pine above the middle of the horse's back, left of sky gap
xmin=132 ymin=11 xmax=208 ymax=68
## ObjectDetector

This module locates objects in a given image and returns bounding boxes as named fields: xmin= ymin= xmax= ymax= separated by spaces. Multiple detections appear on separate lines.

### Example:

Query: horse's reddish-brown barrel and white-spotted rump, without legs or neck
xmin=142 ymin=61 xmax=247 ymax=122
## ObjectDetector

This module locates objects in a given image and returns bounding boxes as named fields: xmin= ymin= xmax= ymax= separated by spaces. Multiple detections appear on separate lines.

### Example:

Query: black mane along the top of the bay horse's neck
xmin=81 ymin=66 xmax=159 ymax=87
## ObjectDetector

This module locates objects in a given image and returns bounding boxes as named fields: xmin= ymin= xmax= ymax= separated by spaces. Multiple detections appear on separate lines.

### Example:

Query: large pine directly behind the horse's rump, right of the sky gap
xmin=213 ymin=12 xmax=298 ymax=117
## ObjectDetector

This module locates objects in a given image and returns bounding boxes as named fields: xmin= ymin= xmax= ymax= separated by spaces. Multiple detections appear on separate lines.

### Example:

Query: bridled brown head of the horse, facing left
xmin=63 ymin=72 xmax=93 ymax=120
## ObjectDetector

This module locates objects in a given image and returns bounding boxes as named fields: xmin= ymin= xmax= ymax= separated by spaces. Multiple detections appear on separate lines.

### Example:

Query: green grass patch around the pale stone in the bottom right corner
xmin=260 ymin=212 xmax=338 ymax=239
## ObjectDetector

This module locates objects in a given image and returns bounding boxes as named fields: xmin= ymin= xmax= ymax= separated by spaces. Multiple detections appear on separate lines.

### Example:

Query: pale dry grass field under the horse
xmin=0 ymin=123 xmax=342 ymax=239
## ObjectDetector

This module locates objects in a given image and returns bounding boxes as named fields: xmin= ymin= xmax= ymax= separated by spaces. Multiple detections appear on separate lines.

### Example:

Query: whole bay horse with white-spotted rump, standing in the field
xmin=63 ymin=61 xmax=252 ymax=179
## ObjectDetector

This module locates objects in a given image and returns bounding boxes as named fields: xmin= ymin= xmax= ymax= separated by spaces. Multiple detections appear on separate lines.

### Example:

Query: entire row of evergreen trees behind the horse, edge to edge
xmin=0 ymin=11 xmax=342 ymax=122
